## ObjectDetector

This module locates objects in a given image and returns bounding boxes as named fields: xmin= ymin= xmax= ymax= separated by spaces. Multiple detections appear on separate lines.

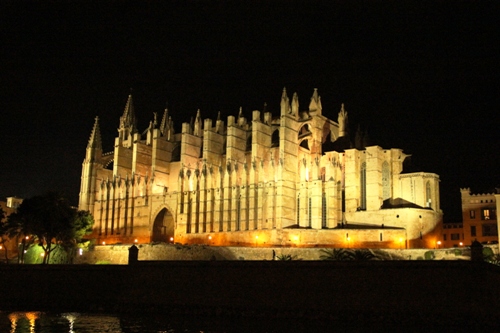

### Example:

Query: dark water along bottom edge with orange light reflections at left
xmin=0 ymin=311 xmax=490 ymax=333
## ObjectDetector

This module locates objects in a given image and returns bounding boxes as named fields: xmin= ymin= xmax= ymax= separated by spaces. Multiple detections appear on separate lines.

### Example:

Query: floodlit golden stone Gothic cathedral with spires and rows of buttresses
xmin=79 ymin=89 xmax=442 ymax=249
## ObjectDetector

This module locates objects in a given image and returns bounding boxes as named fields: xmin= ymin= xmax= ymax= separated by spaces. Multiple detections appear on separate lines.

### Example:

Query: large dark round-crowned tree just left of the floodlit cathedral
xmin=8 ymin=192 xmax=93 ymax=264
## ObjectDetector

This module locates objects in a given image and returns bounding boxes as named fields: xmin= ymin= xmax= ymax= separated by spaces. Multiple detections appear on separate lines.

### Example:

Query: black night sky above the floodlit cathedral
xmin=0 ymin=1 xmax=500 ymax=221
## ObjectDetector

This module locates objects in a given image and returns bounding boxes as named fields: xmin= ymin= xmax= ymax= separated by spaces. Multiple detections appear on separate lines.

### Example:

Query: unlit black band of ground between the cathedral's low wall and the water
xmin=0 ymin=261 xmax=500 ymax=328
